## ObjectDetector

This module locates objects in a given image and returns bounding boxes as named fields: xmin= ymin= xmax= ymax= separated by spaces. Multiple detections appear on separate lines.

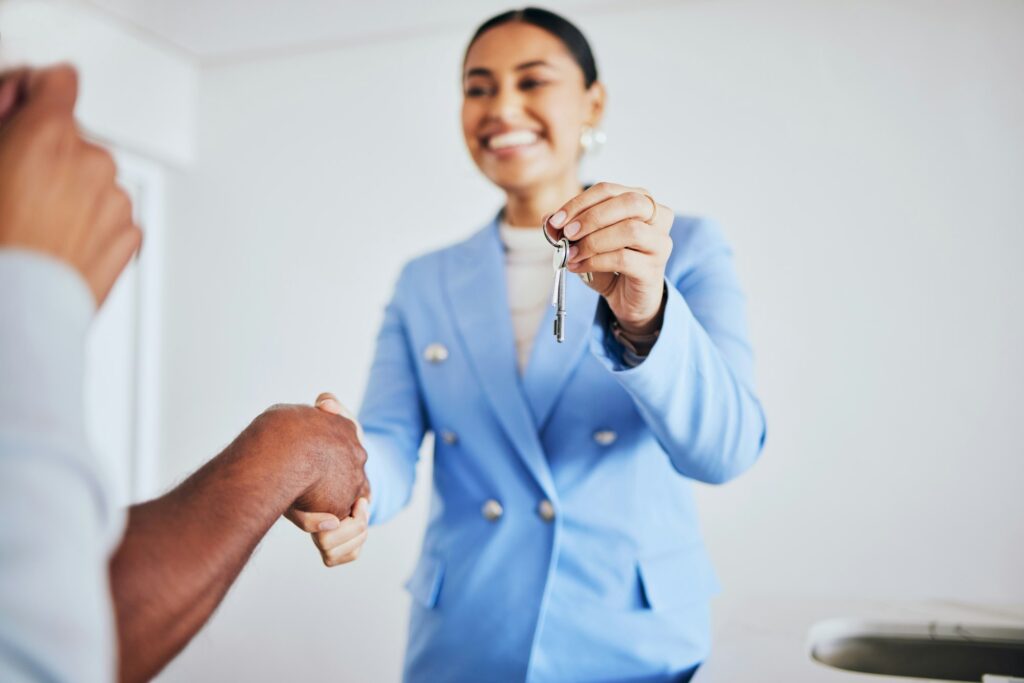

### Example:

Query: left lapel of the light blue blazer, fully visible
xmin=444 ymin=219 xmax=557 ymax=500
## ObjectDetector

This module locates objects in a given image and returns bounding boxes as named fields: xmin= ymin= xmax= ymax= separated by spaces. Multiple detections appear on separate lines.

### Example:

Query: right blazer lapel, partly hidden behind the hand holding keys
xmin=523 ymin=272 xmax=599 ymax=432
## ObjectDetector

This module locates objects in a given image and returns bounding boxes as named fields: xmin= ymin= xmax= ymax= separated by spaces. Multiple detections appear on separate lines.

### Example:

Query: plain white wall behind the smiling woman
xmin=155 ymin=0 xmax=1024 ymax=681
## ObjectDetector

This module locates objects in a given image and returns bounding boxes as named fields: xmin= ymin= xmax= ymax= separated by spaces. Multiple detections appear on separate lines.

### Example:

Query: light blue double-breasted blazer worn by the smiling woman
xmin=359 ymin=217 xmax=765 ymax=683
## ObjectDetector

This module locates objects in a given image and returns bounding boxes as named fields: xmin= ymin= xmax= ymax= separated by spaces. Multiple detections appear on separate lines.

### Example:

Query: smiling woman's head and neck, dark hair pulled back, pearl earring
xmin=462 ymin=9 xmax=604 ymax=219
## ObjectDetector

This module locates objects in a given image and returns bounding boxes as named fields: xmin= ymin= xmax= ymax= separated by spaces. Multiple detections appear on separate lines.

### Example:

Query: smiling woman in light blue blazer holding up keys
xmin=303 ymin=9 xmax=765 ymax=682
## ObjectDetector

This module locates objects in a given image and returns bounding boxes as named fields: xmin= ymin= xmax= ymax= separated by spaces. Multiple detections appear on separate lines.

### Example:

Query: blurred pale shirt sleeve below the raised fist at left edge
xmin=0 ymin=249 xmax=124 ymax=682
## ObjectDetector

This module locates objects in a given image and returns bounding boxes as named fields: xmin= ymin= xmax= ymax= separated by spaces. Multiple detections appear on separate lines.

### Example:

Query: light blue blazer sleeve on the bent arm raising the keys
xmin=591 ymin=217 xmax=765 ymax=483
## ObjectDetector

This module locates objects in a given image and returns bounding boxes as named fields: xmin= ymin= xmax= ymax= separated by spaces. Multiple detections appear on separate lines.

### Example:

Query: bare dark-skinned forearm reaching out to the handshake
xmin=111 ymin=419 xmax=315 ymax=681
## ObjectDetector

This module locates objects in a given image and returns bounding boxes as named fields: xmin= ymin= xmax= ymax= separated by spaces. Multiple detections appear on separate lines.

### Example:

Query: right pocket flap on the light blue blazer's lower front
xmin=637 ymin=545 xmax=720 ymax=610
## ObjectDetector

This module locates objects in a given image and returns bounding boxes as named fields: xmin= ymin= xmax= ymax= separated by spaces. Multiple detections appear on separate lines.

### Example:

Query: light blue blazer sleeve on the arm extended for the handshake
xmin=359 ymin=271 xmax=427 ymax=524
